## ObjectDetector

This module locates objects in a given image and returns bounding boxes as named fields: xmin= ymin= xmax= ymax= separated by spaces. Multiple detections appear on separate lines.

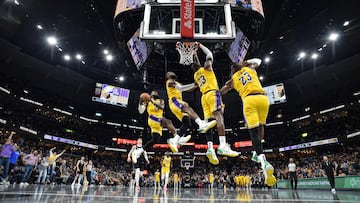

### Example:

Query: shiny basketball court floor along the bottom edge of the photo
xmin=0 ymin=185 xmax=360 ymax=203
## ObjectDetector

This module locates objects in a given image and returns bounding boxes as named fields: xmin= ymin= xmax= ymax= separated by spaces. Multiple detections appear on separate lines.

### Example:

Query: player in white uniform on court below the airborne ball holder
xmin=127 ymin=138 xmax=150 ymax=190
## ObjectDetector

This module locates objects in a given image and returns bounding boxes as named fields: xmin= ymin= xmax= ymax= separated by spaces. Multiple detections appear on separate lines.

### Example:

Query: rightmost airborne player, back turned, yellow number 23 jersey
xmin=220 ymin=58 xmax=276 ymax=186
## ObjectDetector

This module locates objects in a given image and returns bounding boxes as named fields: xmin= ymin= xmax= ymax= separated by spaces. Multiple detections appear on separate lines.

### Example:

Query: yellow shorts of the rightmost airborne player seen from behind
xmin=243 ymin=95 xmax=270 ymax=129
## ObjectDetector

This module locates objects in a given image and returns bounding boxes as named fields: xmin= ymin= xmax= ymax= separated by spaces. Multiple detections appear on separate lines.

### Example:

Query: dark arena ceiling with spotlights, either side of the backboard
xmin=0 ymin=0 xmax=360 ymax=122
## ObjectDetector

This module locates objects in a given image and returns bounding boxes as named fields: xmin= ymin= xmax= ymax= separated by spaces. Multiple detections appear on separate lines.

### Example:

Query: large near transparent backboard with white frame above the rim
xmin=139 ymin=0 xmax=236 ymax=41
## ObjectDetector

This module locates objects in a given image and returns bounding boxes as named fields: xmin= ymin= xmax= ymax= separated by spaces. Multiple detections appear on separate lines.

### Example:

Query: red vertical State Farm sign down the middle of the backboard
xmin=180 ymin=0 xmax=195 ymax=39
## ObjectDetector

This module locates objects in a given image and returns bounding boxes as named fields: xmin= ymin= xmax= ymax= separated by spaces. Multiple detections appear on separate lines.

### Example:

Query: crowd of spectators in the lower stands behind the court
xmin=0 ymin=129 xmax=360 ymax=188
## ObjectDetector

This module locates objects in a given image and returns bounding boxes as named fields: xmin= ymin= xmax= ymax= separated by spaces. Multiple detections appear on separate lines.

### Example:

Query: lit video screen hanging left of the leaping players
xmin=92 ymin=83 xmax=130 ymax=107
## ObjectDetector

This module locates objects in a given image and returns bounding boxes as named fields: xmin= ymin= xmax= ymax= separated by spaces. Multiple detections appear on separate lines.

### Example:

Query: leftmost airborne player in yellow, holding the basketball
xmin=133 ymin=91 xmax=186 ymax=155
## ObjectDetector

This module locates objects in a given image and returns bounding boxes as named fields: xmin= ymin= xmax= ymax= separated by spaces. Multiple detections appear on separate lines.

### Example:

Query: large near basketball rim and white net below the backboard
xmin=176 ymin=42 xmax=198 ymax=65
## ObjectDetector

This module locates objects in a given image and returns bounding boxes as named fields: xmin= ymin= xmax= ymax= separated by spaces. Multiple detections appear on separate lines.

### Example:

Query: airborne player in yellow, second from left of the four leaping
xmin=166 ymin=72 xmax=216 ymax=145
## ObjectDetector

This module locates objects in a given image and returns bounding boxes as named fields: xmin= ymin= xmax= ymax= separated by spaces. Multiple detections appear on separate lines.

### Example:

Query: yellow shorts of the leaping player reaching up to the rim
xmin=201 ymin=90 xmax=224 ymax=119
